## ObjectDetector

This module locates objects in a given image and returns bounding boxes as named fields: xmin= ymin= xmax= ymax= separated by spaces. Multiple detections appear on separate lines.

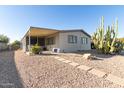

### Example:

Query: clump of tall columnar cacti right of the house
xmin=92 ymin=16 xmax=118 ymax=53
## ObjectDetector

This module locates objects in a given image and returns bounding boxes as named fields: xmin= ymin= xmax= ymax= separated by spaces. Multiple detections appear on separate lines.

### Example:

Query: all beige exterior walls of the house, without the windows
xmin=21 ymin=31 xmax=91 ymax=52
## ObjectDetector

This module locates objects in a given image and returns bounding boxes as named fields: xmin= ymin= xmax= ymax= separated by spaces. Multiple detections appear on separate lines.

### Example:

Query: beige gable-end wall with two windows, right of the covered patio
xmin=59 ymin=31 xmax=91 ymax=52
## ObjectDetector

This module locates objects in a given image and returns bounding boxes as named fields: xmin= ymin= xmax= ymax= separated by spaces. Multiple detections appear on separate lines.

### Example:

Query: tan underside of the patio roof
xmin=27 ymin=28 xmax=59 ymax=36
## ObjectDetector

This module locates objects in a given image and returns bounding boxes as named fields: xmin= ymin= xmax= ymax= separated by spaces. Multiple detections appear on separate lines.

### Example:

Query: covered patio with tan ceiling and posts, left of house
xmin=22 ymin=27 xmax=58 ymax=51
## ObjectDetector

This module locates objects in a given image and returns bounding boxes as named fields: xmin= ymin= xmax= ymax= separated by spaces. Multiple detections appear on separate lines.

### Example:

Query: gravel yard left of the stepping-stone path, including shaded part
xmin=0 ymin=51 xmax=121 ymax=88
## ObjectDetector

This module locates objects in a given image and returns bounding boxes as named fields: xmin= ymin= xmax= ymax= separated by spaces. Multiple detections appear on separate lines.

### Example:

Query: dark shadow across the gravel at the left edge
xmin=0 ymin=51 xmax=23 ymax=88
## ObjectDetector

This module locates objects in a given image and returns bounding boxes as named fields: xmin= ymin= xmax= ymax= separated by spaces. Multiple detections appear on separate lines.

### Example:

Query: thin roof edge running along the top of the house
xmin=22 ymin=26 xmax=91 ymax=39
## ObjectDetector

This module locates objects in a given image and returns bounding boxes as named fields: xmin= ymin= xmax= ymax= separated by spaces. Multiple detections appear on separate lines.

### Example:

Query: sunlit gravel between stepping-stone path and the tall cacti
xmin=60 ymin=51 xmax=124 ymax=78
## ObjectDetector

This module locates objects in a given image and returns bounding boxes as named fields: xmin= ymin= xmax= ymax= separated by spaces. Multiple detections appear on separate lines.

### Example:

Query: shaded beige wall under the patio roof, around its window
xmin=45 ymin=33 xmax=59 ymax=51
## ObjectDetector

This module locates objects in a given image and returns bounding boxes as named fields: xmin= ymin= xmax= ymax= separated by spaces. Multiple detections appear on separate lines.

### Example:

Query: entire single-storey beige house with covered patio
xmin=21 ymin=27 xmax=91 ymax=52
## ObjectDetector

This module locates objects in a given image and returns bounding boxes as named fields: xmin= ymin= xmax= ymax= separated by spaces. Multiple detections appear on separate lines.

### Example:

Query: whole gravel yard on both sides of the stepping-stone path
xmin=0 ymin=50 xmax=124 ymax=88
